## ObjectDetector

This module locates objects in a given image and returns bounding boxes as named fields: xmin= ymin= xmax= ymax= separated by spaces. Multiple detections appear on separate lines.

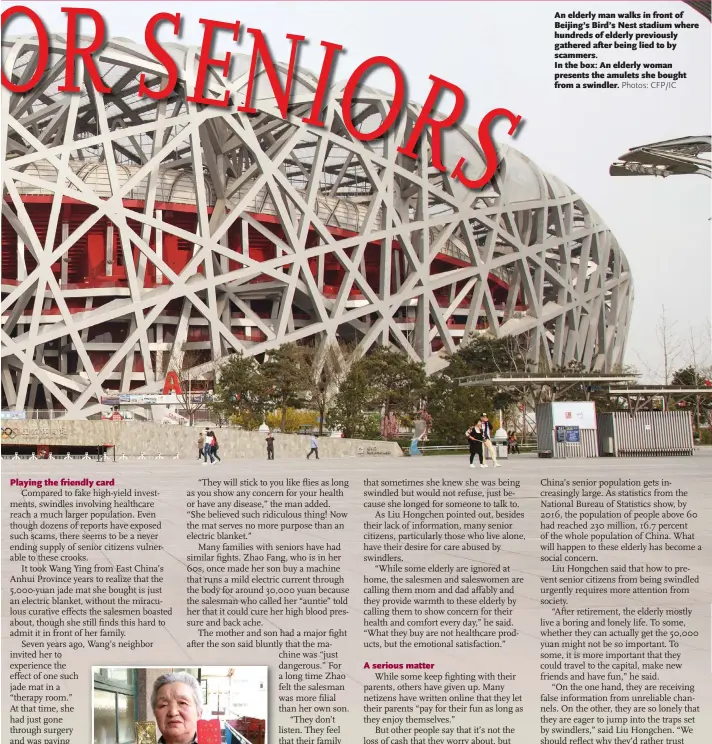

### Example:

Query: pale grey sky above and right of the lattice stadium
xmin=2 ymin=0 xmax=712 ymax=381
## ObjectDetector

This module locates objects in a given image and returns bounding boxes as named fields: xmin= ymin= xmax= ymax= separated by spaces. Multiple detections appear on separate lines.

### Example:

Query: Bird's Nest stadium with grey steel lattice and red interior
xmin=2 ymin=35 xmax=633 ymax=418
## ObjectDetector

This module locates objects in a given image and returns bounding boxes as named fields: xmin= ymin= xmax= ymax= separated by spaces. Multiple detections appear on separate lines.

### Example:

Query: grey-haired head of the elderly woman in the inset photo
xmin=151 ymin=672 xmax=203 ymax=744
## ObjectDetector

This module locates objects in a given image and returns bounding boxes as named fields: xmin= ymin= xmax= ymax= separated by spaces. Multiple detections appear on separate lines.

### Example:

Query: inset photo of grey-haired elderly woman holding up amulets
xmin=93 ymin=666 xmax=267 ymax=744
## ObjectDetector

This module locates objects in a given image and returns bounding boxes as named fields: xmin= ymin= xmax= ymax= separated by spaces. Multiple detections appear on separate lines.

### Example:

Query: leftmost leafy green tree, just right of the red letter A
xmin=209 ymin=352 xmax=270 ymax=428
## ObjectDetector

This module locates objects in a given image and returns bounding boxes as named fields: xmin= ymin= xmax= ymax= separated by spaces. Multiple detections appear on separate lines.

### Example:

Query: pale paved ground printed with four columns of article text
xmin=1 ymin=454 xmax=712 ymax=744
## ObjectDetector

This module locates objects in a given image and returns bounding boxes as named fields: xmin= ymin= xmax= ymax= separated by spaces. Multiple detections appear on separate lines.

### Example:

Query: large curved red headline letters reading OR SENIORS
xmin=2 ymin=5 xmax=522 ymax=189
